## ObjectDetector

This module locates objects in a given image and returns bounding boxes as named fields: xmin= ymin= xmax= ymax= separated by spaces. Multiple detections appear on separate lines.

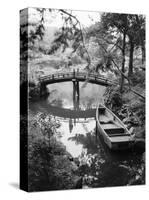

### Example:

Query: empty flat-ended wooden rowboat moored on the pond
xmin=96 ymin=105 xmax=135 ymax=150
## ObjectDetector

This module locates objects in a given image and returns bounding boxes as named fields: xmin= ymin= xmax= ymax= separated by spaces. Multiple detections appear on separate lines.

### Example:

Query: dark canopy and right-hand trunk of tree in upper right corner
xmin=101 ymin=13 xmax=145 ymax=75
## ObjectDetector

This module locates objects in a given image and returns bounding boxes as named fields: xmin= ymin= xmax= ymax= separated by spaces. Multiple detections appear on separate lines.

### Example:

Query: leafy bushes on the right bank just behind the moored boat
xmin=105 ymin=71 xmax=145 ymax=138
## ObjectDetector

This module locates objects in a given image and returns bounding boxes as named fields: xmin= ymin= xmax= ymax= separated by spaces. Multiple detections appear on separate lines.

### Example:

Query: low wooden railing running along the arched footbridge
xmin=39 ymin=71 xmax=117 ymax=85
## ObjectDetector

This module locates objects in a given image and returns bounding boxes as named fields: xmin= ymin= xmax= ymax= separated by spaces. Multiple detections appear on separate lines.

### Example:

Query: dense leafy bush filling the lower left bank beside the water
xmin=28 ymin=113 xmax=79 ymax=191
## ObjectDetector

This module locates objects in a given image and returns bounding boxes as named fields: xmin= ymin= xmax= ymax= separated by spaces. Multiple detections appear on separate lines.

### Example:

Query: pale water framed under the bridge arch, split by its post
xmin=47 ymin=82 xmax=106 ymax=110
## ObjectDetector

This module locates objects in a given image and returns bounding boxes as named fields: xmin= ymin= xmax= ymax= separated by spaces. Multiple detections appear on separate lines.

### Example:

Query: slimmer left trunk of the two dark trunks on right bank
xmin=120 ymin=32 xmax=126 ymax=93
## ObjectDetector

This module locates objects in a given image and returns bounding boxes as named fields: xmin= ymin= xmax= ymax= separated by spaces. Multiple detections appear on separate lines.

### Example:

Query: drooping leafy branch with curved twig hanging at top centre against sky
xmin=49 ymin=9 xmax=91 ymax=70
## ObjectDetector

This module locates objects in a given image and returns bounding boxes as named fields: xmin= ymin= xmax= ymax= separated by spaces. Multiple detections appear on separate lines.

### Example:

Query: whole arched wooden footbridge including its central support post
xmin=39 ymin=71 xmax=116 ymax=110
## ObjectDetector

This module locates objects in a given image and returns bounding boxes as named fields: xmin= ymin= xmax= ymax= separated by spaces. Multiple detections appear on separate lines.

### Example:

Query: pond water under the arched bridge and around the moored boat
xmin=29 ymin=82 xmax=143 ymax=187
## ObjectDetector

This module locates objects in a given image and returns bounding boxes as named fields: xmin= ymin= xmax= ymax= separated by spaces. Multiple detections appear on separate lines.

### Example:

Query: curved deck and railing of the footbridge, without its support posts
xmin=39 ymin=71 xmax=116 ymax=86
